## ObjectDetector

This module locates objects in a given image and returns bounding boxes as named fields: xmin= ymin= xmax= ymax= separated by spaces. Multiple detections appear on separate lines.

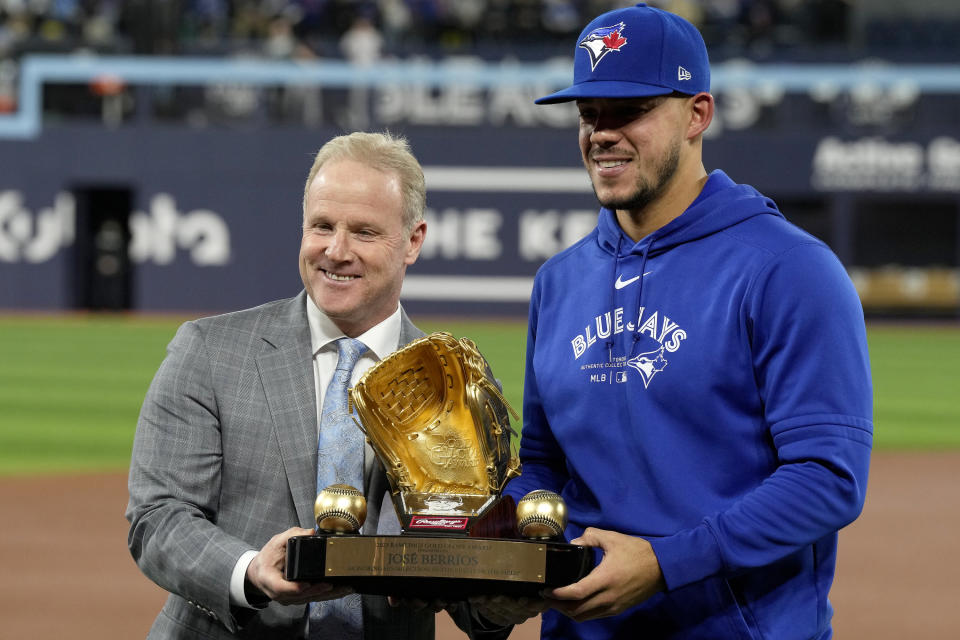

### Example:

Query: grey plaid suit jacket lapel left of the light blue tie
xmin=257 ymin=292 xmax=317 ymax=528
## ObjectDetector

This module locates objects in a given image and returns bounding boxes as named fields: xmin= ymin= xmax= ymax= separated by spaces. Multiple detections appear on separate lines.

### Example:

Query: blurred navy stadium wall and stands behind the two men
xmin=0 ymin=0 xmax=960 ymax=316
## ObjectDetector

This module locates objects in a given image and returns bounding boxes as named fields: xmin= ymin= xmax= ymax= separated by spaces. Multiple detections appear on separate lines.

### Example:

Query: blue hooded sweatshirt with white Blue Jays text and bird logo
xmin=507 ymin=171 xmax=873 ymax=640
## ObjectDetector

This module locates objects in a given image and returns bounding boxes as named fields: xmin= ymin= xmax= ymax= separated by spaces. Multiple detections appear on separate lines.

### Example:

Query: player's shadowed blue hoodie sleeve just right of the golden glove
xmin=505 ymin=276 xmax=568 ymax=500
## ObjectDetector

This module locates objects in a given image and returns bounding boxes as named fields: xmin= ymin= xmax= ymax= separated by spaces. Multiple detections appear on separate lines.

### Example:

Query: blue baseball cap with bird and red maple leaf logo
xmin=534 ymin=3 xmax=710 ymax=104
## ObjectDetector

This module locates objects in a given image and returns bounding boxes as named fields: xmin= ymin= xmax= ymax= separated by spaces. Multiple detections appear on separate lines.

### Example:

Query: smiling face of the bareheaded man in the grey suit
xmin=300 ymin=160 xmax=426 ymax=337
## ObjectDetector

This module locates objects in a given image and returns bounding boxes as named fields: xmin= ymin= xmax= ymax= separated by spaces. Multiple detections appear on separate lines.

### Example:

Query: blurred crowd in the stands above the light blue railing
xmin=0 ymin=0 xmax=960 ymax=69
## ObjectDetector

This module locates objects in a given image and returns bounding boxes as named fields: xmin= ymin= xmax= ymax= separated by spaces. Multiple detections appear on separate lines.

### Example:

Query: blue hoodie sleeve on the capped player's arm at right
xmin=651 ymin=242 xmax=873 ymax=589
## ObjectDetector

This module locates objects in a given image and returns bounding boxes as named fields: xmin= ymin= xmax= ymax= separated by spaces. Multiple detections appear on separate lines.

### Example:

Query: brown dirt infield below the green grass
xmin=0 ymin=452 xmax=960 ymax=640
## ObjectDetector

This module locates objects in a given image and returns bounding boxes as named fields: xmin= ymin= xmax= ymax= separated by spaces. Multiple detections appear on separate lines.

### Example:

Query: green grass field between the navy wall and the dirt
xmin=0 ymin=315 xmax=960 ymax=475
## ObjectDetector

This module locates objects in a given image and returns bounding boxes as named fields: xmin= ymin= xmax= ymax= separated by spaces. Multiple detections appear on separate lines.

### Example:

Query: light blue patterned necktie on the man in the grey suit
xmin=309 ymin=338 xmax=367 ymax=640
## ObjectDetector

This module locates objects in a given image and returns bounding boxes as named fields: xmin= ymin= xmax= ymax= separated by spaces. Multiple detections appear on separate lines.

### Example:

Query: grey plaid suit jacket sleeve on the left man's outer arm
xmin=126 ymin=322 xmax=251 ymax=631
